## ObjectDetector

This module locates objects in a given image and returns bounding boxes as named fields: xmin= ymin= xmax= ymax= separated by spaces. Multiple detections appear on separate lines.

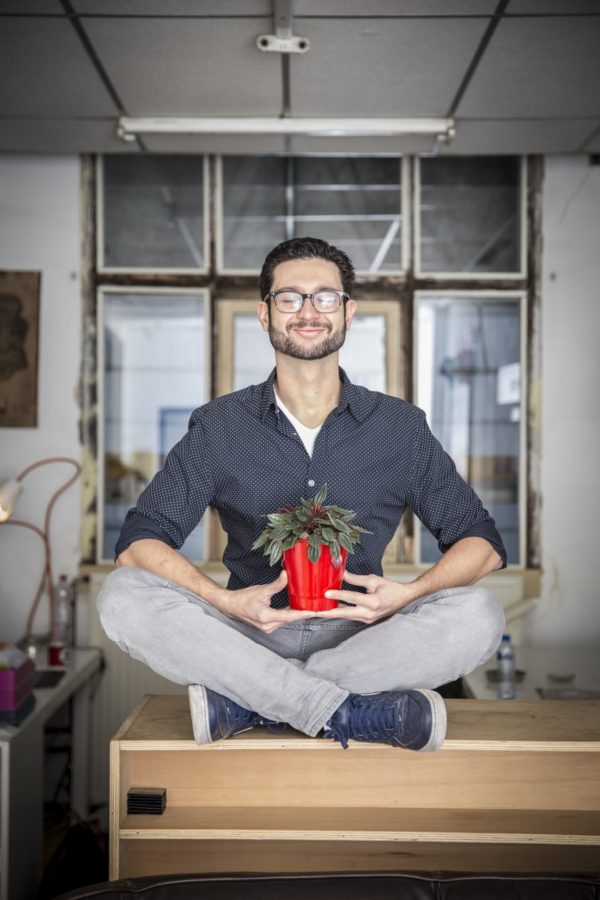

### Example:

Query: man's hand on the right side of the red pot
xmin=314 ymin=571 xmax=415 ymax=625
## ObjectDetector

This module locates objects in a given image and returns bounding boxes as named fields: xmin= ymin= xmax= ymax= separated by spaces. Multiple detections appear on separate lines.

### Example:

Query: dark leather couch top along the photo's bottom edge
xmin=56 ymin=872 xmax=600 ymax=900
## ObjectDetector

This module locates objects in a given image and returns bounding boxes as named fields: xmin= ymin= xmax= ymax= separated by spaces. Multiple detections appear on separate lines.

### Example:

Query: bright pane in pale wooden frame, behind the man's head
xmin=233 ymin=314 xmax=387 ymax=392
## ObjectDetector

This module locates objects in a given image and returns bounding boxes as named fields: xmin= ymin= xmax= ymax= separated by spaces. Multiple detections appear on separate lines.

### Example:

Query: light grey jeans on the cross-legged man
xmin=98 ymin=567 xmax=504 ymax=735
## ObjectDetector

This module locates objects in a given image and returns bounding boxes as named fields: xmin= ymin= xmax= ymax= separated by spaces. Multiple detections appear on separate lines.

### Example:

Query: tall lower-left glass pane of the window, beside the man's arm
xmin=101 ymin=293 xmax=207 ymax=560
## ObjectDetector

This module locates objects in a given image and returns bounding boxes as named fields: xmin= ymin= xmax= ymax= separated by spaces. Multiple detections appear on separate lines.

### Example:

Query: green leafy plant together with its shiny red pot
xmin=252 ymin=484 xmax=371 ymax=611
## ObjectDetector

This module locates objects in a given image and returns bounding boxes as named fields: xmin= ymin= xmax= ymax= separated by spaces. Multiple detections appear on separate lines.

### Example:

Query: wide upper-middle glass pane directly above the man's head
xmin=223 ymin=156 xmax=402 ymax=272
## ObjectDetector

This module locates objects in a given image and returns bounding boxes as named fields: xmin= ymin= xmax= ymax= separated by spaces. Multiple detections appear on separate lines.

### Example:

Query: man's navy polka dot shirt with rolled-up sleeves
xmin=116 ymin=369 xmax=506 ymax=607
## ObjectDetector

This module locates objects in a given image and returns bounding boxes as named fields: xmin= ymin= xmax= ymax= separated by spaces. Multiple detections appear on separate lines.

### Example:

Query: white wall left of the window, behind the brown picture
xmin=0 ymin=155 xmax=81 ymax=641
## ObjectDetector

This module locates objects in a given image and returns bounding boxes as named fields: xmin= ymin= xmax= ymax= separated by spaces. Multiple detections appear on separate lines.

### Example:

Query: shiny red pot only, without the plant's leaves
xmin=283 ymin=541 xmax=348 ymax=612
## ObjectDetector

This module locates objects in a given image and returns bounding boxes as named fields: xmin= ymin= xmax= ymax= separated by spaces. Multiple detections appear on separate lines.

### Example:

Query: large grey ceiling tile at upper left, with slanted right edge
xmin=0 ymin=17 xmax=116 ymax=117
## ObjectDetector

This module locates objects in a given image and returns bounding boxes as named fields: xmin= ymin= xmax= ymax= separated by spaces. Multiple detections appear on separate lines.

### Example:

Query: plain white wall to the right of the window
xmin=526 ymin=157 xmax=600 ymax=646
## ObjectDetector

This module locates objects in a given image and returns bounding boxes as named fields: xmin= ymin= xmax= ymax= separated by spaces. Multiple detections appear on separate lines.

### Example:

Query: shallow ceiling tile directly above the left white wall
xmin=0 ymin=119 xmax=138 ymax=153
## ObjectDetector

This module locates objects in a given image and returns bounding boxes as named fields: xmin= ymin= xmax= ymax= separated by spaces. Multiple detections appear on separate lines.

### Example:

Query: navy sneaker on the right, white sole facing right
xmin=323 ymin=690 xmax=446 ymax=750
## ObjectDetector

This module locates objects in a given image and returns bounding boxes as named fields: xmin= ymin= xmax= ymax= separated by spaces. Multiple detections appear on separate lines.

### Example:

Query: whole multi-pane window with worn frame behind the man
xmin=87 ymin=155 xmax=535 ymax=566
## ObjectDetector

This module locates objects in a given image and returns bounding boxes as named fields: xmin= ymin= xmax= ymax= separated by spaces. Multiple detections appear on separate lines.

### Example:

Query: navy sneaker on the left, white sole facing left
xmin=188 ymin=684 xmax=277 ymax=744
